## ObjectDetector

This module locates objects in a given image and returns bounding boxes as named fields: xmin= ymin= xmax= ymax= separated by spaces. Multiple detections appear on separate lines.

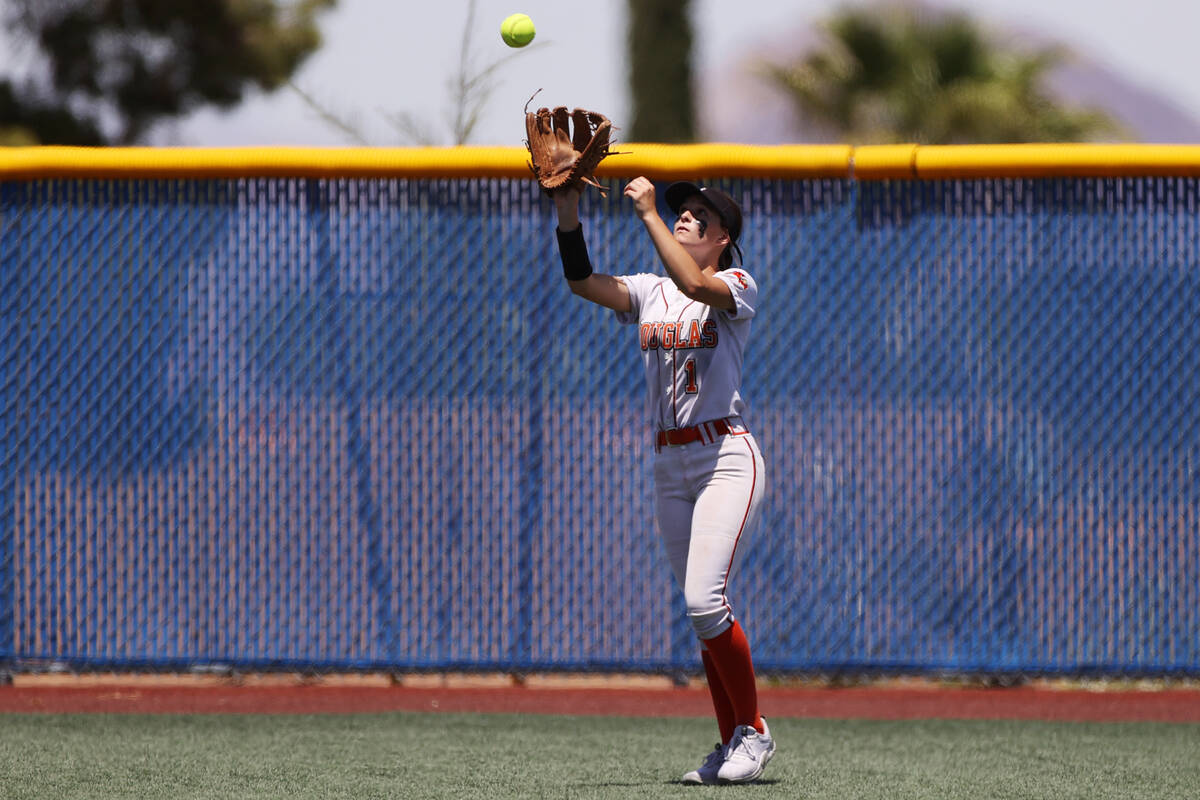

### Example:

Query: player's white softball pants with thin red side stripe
xmin=654 ymin=432 xmax=766 ymax=639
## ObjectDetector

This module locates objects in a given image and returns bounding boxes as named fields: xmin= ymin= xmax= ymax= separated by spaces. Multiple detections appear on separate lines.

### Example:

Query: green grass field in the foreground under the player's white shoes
xmin=0 ymin=714 xmax=1200 ymax=800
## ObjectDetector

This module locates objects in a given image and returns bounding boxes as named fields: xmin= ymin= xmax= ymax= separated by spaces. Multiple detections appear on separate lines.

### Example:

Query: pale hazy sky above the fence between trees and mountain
xmin=162 ymin=0 xmax=1200 ymax=146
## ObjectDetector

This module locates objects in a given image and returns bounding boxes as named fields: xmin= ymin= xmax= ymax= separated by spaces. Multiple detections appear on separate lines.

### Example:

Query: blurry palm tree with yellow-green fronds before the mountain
xmin=764 ymin=5 xmax=1120 ymax=144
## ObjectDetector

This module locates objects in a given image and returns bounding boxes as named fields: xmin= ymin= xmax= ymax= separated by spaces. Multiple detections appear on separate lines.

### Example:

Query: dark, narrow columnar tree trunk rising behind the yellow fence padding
xmin=629 ymin=0 xmax=696 ymax=142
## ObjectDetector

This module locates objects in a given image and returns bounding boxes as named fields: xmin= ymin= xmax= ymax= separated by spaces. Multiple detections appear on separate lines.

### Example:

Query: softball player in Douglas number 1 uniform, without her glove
xmin=553 ymin=178 xmax=775 ymax=783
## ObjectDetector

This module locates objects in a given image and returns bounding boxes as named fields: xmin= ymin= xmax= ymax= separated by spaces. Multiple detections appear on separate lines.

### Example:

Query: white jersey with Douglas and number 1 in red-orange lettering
xmin=617 ymin=267 xmax=758 ymax=431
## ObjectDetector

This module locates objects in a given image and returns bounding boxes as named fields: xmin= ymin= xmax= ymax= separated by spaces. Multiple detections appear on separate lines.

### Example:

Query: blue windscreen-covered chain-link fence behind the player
xmin=0 ymin=178 xmax=1200 ymax=674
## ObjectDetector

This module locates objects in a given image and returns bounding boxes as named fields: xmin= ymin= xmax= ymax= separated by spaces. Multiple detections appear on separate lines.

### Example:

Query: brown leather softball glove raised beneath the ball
xmin=526 ymin=106 xmax=616 ymax=197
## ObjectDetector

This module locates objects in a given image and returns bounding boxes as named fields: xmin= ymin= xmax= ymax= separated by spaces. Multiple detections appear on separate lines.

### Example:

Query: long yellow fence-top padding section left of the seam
xmin=0 ymin=144 xmax=851 ymax=180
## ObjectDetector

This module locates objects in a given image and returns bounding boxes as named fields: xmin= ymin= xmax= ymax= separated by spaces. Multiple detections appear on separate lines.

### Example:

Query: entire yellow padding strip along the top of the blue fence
xmin=7 ymin=143 xmax=1200 ymax=180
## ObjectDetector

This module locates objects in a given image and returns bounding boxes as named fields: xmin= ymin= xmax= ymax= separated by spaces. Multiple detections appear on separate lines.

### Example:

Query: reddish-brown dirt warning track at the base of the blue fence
xmin=0 ymin=685 xmax=1200 ymax=722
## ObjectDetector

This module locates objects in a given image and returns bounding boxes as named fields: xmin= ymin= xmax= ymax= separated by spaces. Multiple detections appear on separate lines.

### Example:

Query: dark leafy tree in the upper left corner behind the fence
xmin=0 ymin=0 xmax=337 ymax=145
